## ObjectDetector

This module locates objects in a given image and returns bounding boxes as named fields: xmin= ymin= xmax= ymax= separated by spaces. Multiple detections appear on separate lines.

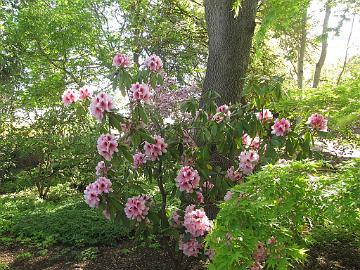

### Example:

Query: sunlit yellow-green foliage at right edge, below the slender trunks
xmin=274 ymin=77 xmax=360 ymax=143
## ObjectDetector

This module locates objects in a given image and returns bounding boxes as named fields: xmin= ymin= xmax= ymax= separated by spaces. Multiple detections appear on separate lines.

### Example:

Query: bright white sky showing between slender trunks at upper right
xmin=308 ymin=0 xmax=360 ymax=65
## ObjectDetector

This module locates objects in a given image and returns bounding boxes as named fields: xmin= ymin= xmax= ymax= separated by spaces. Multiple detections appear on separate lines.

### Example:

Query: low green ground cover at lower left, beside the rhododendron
xmin=0 ymin=186 xmax=127 ymax=248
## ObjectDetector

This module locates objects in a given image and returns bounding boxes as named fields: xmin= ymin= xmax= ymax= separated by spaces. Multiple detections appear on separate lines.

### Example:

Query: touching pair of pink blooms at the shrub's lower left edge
xmin=84 ymin=177 xmax=112 ymax=208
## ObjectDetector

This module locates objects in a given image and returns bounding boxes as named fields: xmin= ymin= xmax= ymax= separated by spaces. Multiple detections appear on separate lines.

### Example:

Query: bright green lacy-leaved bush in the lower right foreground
xmin=207 ymin=160 xmax=360 ymax=269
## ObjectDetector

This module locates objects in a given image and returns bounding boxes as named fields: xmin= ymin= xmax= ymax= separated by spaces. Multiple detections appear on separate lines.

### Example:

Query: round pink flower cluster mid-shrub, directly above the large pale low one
xmin=175 ymin=166 xmax=200 ymax=193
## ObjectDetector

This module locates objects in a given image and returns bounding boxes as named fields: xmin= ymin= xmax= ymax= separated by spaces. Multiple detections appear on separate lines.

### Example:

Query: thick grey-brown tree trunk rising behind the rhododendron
xmin=203 ymin=0 xmax=258 ymax=104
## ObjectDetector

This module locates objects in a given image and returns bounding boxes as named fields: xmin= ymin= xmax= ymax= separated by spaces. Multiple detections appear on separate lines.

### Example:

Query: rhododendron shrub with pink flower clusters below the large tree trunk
xmin=63 ymin=50 xmax=324 ymax=267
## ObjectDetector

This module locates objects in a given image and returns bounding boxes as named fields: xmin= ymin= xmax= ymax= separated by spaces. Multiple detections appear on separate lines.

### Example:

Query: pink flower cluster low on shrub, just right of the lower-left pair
xmin=124 ymin=195 xmax=150 ymax=222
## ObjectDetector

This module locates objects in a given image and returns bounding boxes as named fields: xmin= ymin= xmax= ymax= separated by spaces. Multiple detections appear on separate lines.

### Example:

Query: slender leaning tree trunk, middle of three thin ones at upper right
xmin=313 ymin=2 xmax=331 ymax=88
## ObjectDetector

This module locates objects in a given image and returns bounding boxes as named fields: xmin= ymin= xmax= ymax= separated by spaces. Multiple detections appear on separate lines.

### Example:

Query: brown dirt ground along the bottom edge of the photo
xmin=0 ymin=240 xmax=360 ymax=270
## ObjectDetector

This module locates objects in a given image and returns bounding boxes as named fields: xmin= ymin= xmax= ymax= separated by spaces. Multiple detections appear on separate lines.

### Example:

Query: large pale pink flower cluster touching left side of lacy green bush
xmin=184 ymin=205 xmax=211 ymax=237
